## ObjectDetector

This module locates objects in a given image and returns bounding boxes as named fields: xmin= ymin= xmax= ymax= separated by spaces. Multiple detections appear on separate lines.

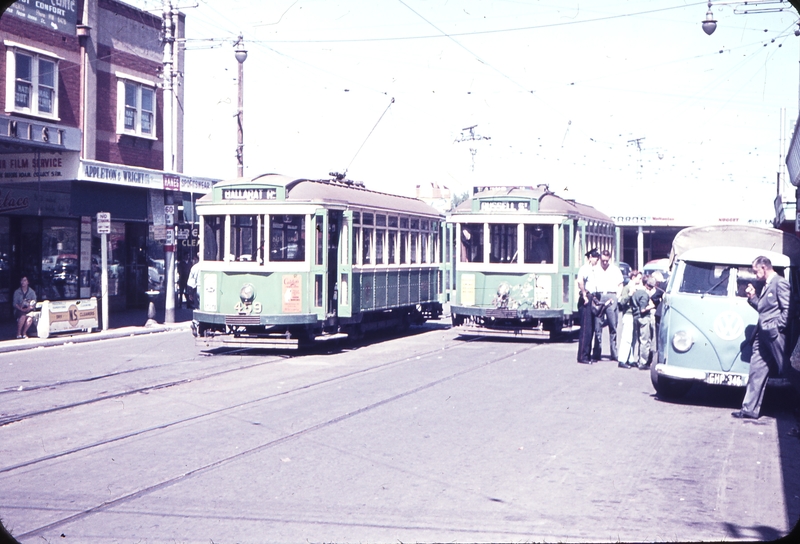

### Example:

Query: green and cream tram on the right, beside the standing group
xmin=447 ymin=185 xmax=616 ymax=339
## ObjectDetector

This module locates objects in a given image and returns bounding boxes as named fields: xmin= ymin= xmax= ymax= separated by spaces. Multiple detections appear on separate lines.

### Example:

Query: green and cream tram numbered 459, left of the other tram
xmin=192 ymin=174 xmax=444 ymax=349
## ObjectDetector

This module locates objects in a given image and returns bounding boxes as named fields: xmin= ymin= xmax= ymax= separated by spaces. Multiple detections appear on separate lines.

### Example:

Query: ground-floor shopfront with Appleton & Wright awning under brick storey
xmin=0 ymin=147 xmax=213 ymax=319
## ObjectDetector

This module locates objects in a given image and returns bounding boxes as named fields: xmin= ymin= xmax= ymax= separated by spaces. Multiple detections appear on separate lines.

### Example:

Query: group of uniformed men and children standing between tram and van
xmin=577 ymin=249 xmax=664 ymax=370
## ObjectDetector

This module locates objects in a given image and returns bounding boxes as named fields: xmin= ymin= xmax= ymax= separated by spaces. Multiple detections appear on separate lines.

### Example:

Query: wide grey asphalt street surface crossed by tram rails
xmin=0 ymin=322 xmax=800 ymax=544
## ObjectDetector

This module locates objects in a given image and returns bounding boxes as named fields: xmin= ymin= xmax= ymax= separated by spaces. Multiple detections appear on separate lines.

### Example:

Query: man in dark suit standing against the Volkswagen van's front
xmin=731 ymin=256 xmax=790 ymax=419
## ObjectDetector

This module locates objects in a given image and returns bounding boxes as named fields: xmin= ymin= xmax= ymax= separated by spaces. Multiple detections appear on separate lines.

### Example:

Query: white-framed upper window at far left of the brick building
xmin=4 ymin=40 xmax=60 ymax=121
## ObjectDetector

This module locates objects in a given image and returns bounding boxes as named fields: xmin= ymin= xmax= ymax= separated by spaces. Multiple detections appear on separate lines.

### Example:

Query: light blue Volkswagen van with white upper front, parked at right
xmin=650 ymin=225 xmax=800 ymax=397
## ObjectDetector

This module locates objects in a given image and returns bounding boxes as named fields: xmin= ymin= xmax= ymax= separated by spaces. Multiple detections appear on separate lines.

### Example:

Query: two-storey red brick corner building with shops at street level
xmin=0 ymin=0 xmax=212 ymax=316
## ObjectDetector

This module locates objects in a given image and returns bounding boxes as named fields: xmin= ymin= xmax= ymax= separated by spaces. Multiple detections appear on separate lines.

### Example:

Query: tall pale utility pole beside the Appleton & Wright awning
xmin=163 ymin=0 xmax=175 ymax=323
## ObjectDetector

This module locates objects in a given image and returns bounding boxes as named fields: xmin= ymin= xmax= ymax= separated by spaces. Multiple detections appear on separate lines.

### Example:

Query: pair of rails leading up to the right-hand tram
xmin=14 ymin=339 xmax=542 ymax=538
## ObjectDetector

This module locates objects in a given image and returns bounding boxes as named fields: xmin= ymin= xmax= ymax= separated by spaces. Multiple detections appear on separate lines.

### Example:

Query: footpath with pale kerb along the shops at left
xmin=0 ymin=306 xmax=192 ymax=353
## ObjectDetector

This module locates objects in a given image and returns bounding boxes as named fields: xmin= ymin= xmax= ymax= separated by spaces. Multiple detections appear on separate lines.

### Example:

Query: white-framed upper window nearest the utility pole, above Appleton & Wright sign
xmin=117 ymin=74 xmax=156 ymax=139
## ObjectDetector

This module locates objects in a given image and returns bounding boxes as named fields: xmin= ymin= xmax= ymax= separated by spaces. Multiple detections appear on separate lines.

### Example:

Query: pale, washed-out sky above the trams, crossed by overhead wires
xmin=129 ymin=0 xmax=800 ymax=219
